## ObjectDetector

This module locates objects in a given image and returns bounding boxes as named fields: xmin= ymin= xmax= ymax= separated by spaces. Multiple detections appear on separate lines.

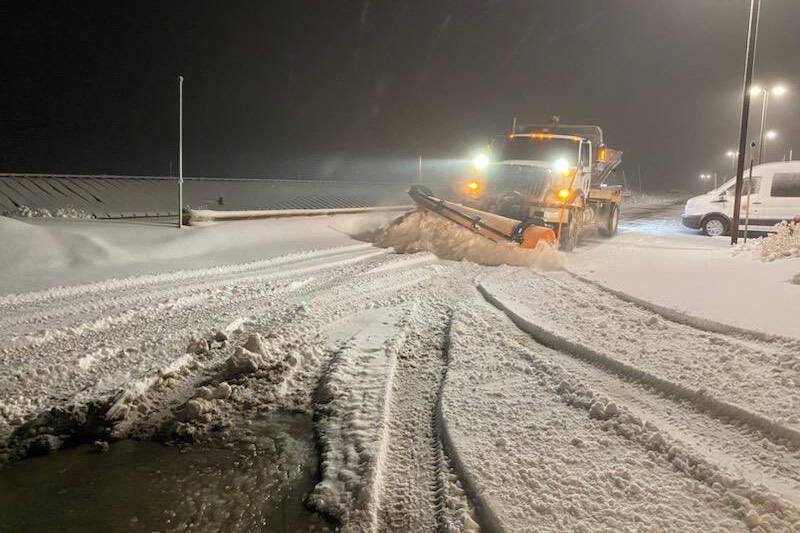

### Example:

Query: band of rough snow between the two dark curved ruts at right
xmin=478 ymin=274 xmax=800 ymax=447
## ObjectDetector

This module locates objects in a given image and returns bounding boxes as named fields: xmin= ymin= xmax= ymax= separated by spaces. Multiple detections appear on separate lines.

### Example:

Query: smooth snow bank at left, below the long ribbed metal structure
xmin=0 ymin=212 xmax=396 ymax=294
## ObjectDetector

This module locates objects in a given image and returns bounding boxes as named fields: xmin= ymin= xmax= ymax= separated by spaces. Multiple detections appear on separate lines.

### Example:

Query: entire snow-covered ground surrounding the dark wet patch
xmin=0 ymin=198 xmax=800 ymax=532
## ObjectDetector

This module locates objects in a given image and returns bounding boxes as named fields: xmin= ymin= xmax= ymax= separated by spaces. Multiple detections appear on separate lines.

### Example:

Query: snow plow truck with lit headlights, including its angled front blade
xmin=409 ymin=124 xmax=622 ymax=251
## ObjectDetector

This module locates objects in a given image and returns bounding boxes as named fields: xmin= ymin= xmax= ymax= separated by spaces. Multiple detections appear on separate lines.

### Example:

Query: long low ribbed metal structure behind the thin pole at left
xmin=0 ymin=173 xmax=410 ymax=218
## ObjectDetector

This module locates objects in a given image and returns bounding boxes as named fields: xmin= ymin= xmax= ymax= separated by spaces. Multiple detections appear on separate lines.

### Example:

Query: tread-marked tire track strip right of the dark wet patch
xmin=309 ymin=289 xmax=476 ymax=532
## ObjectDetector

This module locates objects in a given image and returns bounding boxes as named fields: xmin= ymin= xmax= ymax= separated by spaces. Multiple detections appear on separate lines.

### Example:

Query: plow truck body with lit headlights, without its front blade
xmin=460 ymin=125 xmax=621 ymax=248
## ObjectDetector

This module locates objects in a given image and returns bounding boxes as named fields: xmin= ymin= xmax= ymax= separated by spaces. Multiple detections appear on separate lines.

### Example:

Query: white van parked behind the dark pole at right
xmin=683 ymin=161 xmax=800 ymax=236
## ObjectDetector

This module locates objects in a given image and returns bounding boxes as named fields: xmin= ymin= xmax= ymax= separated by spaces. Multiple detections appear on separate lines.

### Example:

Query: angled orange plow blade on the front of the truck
xmin=408 ymin=185 xmax=556 ymax=248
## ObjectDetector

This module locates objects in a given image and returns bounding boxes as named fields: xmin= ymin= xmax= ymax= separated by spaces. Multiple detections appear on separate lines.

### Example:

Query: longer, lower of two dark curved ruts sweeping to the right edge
xmin=477 ymin=282 xmax=800 ymax=445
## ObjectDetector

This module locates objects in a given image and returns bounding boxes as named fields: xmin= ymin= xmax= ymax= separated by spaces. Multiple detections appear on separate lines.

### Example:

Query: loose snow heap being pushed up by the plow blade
xmin=375 ymin=211 xmax=564 ymax=270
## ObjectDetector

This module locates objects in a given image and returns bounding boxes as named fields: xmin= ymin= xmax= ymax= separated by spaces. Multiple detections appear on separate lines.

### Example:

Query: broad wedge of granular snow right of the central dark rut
xmin=444 ymin=302 xmax=800 ymax=532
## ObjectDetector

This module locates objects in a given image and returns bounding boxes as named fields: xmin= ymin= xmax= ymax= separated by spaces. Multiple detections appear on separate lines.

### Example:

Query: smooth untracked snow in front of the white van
xmin=567 ymin=205 xmax=800 ymax=338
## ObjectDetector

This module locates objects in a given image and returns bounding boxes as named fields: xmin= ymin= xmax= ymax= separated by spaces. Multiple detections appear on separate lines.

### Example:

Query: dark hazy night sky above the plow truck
xmin=0 ymin=0 xmax=800 ymax=190
